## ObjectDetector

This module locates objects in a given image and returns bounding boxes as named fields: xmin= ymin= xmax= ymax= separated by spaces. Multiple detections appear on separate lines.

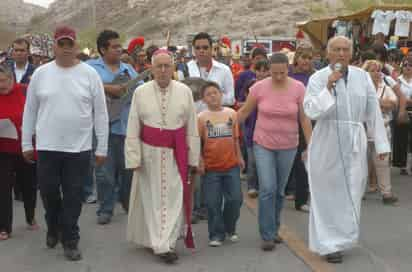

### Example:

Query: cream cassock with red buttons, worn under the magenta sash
xmin=125 ymin=81 xmax=200 ymax=254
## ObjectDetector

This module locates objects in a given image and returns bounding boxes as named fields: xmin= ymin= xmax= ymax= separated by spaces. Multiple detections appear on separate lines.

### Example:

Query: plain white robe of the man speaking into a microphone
xmin=303 ymin=66 xmax=390 ymax=255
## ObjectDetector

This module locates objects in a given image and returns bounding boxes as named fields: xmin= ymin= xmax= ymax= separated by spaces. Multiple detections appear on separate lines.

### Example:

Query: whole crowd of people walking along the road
xmin=0 ymin=26 xmax=412 ymax=264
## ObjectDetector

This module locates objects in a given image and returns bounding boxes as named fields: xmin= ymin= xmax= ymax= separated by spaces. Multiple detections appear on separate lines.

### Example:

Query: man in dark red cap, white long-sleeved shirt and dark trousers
xmin=22 ymin=27 xmax=109 ymax=261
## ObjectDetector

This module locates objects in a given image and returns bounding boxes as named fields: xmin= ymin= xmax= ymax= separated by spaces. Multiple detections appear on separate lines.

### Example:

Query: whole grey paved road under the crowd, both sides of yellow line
xmin=0 ymin=172 xmax=412 ymax=272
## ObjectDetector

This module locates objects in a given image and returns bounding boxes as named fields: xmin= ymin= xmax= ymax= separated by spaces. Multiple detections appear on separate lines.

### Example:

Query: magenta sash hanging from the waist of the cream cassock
xmin=140 ymin=124 xmax=195 ymax=248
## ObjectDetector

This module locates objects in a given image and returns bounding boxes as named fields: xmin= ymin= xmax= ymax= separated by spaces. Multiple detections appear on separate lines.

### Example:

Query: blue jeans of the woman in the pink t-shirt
xmin=253 ymin=143 xmax=296 ymax=241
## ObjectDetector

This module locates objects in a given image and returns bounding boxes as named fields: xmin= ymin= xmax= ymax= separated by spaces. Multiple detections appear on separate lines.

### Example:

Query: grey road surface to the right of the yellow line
xmin=283 ymin=169 xmax=412 ymax=272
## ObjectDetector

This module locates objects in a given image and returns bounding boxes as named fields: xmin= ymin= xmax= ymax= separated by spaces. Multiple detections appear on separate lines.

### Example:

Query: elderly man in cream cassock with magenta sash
xmin=125 ymin=50 xmax=200 ymax=263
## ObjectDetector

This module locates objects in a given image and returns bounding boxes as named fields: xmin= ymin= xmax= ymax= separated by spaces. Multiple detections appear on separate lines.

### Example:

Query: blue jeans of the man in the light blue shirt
xmin=95 ymin=134 xmax=133 ymax=215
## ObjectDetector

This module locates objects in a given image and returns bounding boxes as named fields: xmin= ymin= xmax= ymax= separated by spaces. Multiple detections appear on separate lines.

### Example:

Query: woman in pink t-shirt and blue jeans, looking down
xmin=238 ymin=53 xmax=312 ymax=251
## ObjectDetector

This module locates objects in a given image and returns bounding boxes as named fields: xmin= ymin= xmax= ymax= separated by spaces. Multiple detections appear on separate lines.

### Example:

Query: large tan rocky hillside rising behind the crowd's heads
xmin=25 ymin=0 xmax=339 ymax=43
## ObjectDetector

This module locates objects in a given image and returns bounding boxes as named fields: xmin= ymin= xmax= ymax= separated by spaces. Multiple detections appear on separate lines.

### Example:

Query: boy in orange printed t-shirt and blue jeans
xmin=198 ymin=82 xmax=245 ymax=247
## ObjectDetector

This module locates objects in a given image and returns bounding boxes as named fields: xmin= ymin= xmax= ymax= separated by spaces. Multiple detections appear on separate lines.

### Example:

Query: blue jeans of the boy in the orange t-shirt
xmin=203 ymin=167 xmax=242 ymax=241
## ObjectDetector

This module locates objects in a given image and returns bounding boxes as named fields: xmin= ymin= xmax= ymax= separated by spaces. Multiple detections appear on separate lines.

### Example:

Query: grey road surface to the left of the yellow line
xmin=0 ymin=199 xmax=310 ymax=272
